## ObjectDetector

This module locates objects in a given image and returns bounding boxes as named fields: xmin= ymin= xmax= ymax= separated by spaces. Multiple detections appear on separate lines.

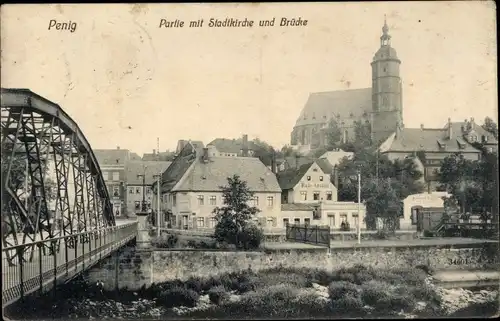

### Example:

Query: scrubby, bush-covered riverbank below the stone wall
xmin=3 ymin=265 xmax=498 ymax=320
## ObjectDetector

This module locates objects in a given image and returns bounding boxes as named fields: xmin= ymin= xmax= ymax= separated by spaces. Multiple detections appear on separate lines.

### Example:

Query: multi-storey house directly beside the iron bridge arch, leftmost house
xmin=93 ymin=146 xmax=141 ymax=217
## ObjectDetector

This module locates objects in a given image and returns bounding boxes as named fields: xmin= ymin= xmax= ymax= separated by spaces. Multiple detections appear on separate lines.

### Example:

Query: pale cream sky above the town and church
xmin=1 ymin=1 xmax=498 ymax=154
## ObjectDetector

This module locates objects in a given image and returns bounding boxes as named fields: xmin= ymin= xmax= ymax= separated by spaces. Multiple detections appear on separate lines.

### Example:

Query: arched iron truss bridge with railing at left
xmin=1 ymin=88 xmax=137 ymax=305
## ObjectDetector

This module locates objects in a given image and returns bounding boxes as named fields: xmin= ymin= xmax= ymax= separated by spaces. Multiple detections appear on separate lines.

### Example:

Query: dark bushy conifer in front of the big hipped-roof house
xmin=213 ymin=175 xmax=262 ymax=249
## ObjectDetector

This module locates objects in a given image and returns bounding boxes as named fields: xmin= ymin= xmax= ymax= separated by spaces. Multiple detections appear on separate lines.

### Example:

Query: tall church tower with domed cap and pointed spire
xmin=371 ymin=18 xmax=403 ymax=144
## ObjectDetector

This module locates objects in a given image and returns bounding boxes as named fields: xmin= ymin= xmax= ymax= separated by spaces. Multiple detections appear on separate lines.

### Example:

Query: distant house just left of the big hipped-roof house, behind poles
xmin=125 ymin=161 xmax=172 ymax=217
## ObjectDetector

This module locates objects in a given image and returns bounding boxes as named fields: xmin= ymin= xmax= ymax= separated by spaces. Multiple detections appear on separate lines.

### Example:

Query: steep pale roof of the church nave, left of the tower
xmin=295 ymin=88 xmax=372 ymax=126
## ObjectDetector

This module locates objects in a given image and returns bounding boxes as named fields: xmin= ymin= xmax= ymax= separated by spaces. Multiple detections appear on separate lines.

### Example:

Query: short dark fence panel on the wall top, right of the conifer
xmin=286 ymin=224 xmax=330 ymax=247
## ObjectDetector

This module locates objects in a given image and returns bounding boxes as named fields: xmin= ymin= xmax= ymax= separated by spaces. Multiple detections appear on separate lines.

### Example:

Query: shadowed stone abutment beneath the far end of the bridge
xmin=84 ymin=243 xmax=153 ymax=290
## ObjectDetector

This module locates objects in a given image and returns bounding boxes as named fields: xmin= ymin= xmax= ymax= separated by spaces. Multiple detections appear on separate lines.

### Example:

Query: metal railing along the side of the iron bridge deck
xmin=2 ymin=222 xmax=137 ymax=305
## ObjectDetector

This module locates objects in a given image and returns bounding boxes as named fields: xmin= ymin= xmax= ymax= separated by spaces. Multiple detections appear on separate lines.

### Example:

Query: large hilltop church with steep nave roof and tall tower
xmin=291 ymin=18 xmax=404 ymax=152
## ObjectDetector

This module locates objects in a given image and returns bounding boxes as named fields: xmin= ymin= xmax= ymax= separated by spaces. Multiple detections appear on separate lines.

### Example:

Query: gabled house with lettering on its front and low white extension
xmin=277 ymin=160 xmax=366 ymax=229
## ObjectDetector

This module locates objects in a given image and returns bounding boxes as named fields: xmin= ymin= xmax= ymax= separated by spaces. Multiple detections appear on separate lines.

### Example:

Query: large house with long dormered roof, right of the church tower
xmin=379 ymin=119 xmax=481 ymax=191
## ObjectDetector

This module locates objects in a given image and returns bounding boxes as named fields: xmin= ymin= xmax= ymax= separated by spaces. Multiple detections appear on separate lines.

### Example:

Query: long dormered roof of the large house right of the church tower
xmin=382 ymin=128 xmax=480 ymax=153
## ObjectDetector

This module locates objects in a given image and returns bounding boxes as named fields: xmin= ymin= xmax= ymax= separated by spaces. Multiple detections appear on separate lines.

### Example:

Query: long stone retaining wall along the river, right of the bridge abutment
xmin=153 ymin=247 xmax=498 ymax=282
